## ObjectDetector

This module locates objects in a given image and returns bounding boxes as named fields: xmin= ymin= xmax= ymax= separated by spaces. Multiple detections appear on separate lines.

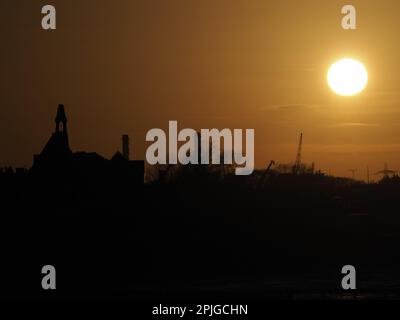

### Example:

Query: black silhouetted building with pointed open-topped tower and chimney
xmin=31 ymin=105 xmax=144 ymax=187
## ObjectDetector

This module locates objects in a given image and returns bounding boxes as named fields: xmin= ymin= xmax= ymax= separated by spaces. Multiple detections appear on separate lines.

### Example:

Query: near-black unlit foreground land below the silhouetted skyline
xmin=0 ymin=170 xmax=400 ymax=299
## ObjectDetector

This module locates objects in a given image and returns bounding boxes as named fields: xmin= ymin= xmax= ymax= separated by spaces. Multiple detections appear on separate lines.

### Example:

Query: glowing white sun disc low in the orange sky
xmin=328 ymin=58 xmax=368 ymax=96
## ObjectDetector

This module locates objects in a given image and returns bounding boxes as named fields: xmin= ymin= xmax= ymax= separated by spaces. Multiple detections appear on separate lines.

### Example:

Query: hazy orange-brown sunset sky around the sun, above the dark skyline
xmin=0 ymin=0 xmax=400 ymax=178
